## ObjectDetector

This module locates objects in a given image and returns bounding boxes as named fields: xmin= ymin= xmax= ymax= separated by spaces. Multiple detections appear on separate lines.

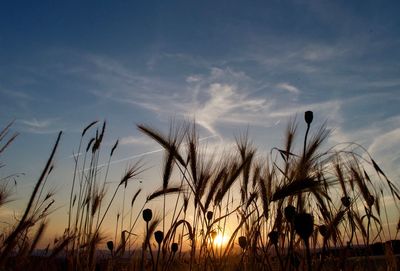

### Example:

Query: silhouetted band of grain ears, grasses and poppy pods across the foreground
xmin=0 ymin=111 xmax=400 ymax=271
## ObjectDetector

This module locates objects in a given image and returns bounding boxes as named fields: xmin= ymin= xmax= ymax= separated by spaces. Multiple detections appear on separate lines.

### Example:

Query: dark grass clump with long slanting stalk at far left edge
xmin=0 ymin=123 xmax=61 ymax=270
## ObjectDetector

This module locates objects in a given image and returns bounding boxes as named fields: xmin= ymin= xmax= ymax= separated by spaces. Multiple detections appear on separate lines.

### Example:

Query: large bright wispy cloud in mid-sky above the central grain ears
xmin=77 ymin=56 xmax=339 ymax=138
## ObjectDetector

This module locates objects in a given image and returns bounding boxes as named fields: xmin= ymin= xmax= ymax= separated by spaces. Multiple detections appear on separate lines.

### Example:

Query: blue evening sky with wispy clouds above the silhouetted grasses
xmin=0 ymin=0 xmax=400 ymax=242
